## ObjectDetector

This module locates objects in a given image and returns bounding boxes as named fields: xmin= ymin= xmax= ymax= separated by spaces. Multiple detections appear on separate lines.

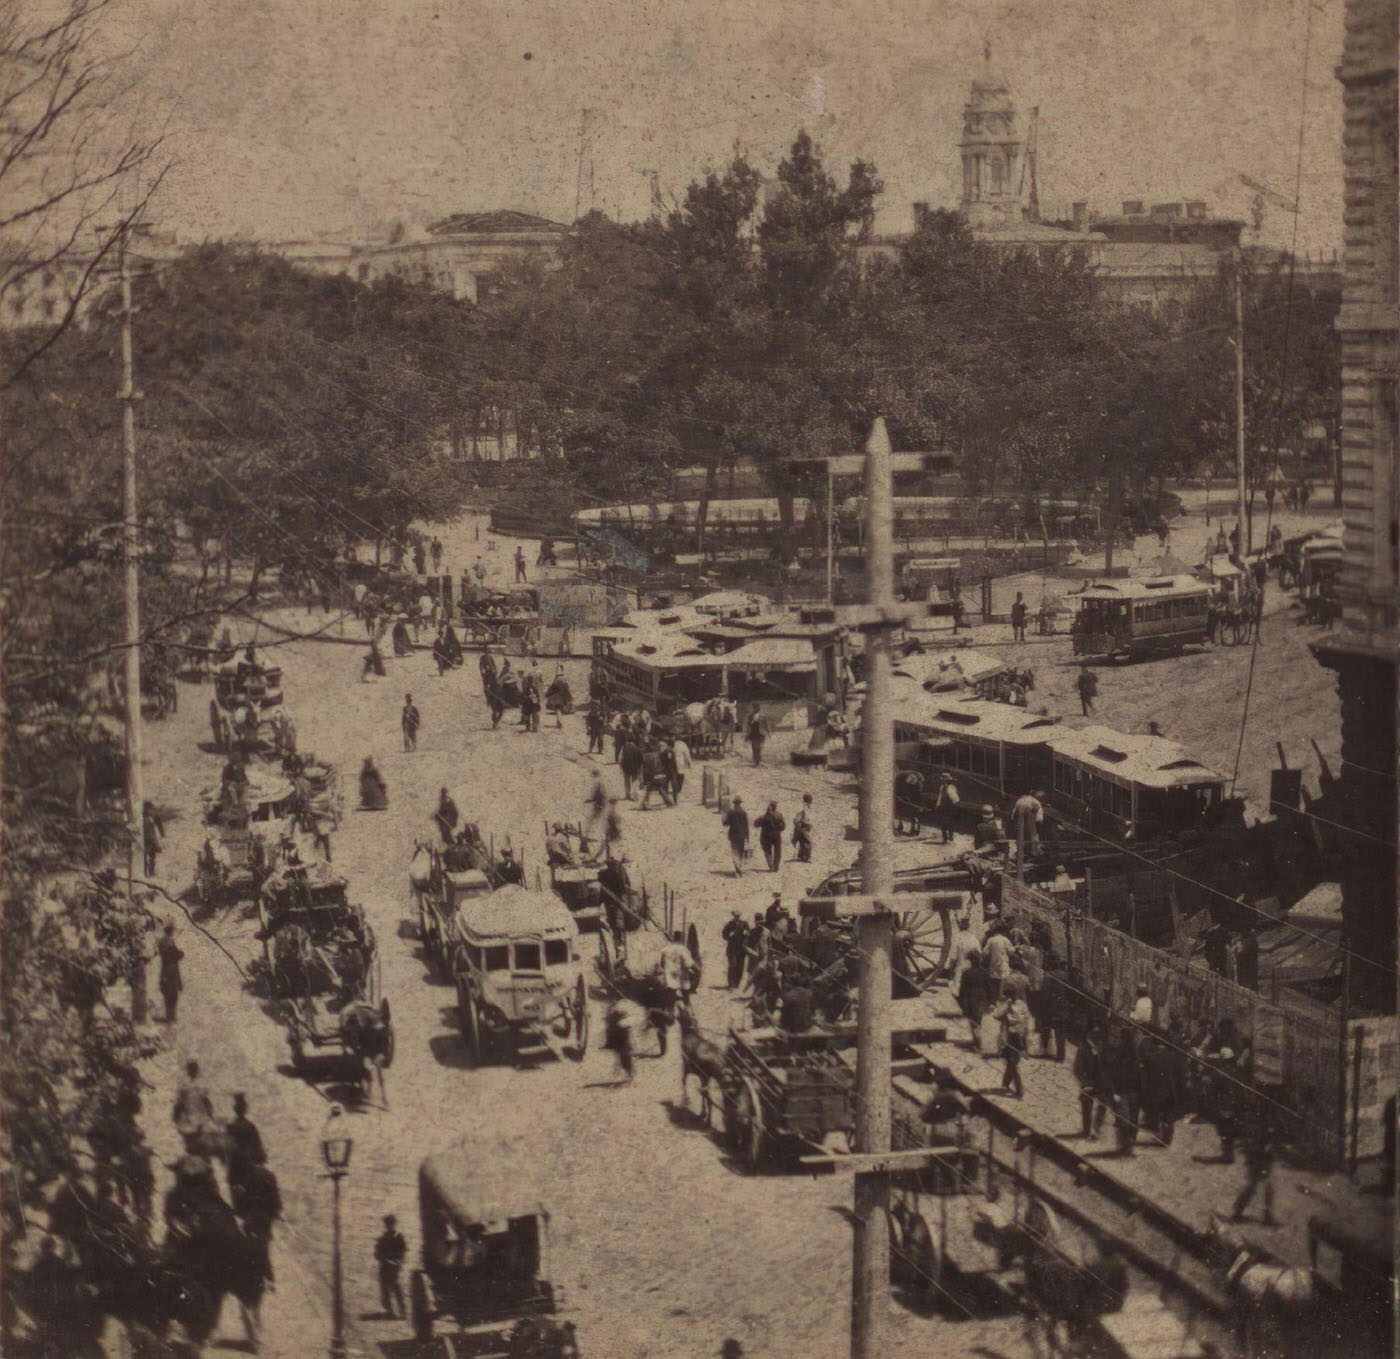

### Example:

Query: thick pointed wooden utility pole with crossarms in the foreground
xmin=851 ymin=418 xmax=897 ymax=1359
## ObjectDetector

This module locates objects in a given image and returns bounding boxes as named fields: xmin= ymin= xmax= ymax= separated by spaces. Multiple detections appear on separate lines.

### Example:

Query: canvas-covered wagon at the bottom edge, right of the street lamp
xmin=409 ymin=1145 xmax=578 ymax=1359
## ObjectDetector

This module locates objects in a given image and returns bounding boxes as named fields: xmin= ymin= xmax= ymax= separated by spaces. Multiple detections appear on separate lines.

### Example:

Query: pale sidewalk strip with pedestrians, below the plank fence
xmin=923 ymin=987 xmax=1392 ymax=1265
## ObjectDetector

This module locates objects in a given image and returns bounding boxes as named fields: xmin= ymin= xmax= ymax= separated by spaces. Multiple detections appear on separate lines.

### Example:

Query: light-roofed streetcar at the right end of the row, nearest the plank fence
xmin=1044 ymin=726 xmax=1225 ymax=841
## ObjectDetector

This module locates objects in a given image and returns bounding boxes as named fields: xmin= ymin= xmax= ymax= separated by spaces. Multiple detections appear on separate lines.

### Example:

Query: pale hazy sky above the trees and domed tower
xmin=101 ymin=0 xmax=1343 ymax=252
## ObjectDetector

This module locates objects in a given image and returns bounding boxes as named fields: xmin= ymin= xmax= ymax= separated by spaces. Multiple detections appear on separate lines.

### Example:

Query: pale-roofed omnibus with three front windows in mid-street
xmin=447 ymin=885 xmax=588 ymax=1065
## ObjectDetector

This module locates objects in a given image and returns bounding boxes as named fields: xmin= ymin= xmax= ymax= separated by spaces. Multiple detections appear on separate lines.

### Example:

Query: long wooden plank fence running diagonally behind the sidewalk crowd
xmin=1002 ymin=879 xmax=1349 ymax=1164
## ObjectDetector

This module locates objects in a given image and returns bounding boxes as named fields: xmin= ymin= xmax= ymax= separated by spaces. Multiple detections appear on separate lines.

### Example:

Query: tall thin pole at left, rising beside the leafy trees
xmin=116 ymin=239 xmax=146 ymax=1023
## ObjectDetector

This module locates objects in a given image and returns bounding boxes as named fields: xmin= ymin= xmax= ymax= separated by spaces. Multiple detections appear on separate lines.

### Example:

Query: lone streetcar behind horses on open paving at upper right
xmin=1070 ymin=575 xmax=1211 ymax=661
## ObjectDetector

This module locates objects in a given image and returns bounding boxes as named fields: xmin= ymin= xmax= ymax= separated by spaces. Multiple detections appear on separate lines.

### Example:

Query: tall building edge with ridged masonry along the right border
xmin=1315 ymin=0 xmax=1400 ymax=1011
